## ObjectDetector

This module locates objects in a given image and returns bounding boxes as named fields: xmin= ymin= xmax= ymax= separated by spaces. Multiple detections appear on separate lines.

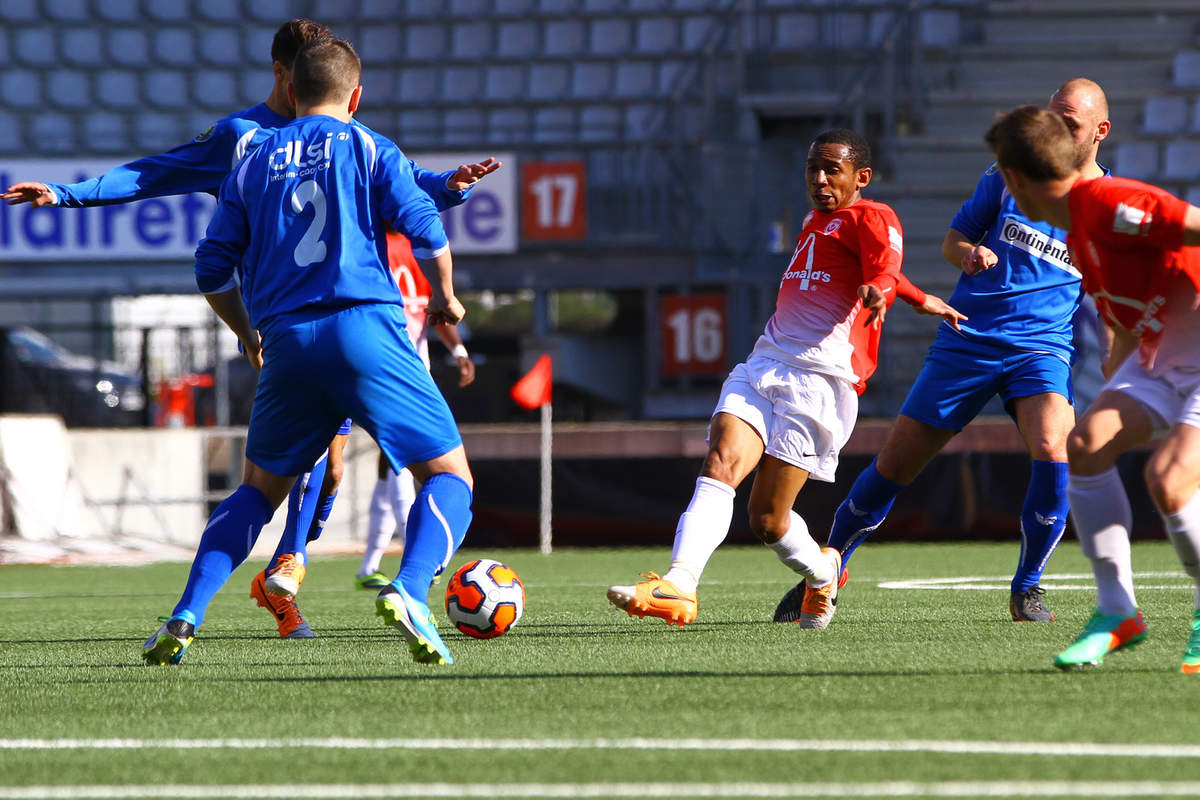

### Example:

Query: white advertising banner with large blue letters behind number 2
xmin=0 ymin=154 xmax=517 ymax=263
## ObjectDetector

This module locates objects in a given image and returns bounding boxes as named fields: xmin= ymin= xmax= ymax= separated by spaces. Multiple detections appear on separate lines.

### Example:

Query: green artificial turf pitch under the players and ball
xmin=0 ymin=542 xmax=1200 ymax=798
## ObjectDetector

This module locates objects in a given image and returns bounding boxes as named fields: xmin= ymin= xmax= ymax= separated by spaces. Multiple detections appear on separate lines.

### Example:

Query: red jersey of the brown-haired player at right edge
xmin=1067 ymin=178 xmax=1200 ymax=367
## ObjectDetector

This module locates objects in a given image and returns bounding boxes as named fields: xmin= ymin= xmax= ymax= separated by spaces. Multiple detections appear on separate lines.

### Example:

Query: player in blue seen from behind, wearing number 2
xmin=143 ymin=37 xmax=472 ymax=664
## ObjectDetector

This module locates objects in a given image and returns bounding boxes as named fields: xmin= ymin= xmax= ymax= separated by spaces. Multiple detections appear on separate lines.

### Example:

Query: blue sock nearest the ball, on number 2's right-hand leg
xmin=392 ymin=473 xmax=472 ymax=600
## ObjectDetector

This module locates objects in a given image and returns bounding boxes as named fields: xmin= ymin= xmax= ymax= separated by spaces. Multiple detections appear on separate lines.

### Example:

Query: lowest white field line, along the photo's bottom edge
xmin=0 ymin=781 xmax=1200 ymax=800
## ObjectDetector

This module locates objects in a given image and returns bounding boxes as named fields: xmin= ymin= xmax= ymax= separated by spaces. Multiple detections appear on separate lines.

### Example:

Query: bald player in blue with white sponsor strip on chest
xmin=775 ymin=78 xmax=1110 ymax=624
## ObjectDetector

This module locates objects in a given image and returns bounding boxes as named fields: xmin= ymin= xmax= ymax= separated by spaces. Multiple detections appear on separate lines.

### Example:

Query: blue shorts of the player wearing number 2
xmin=246 ymin=303 xmax=462 ymax=475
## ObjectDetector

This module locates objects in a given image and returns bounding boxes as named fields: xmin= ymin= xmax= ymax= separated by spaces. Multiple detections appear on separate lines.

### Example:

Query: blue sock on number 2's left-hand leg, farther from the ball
xmin=172 ymin=483 xmax=275 ymax=627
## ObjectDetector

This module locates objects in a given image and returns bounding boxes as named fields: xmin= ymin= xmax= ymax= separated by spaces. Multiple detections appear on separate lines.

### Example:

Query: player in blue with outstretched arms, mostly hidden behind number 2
xmin=0 ymin=18 xmax=500 ymax=638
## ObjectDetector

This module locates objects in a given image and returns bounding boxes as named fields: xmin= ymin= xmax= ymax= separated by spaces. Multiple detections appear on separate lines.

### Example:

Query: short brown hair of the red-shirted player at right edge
xmin=984 ymin=106 xmax=1078 ymax=181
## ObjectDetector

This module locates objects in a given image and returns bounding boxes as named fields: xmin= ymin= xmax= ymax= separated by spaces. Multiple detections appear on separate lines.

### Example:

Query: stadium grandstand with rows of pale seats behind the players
xmin=0 ymin=0 xmax=1200 ymax=561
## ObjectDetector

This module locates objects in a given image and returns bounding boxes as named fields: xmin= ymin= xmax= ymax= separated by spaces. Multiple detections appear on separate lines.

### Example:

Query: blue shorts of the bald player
xmin=900 ymin=337 xmax=1075 ymax=431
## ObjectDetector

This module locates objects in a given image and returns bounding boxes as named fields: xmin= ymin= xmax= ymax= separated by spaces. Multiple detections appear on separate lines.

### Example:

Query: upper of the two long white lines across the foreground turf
xmin=0 ymin=736 xmax=1200 ymax=758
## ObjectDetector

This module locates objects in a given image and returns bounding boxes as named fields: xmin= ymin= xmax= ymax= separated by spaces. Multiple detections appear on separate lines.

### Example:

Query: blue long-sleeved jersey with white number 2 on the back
xmin=196 ymin=115 xmax=449 ymax=336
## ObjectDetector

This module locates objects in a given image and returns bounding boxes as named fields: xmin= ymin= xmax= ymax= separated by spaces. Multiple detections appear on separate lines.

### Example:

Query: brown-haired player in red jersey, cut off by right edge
xmin=986 ymin=106 xmax=1200 ymax=674
